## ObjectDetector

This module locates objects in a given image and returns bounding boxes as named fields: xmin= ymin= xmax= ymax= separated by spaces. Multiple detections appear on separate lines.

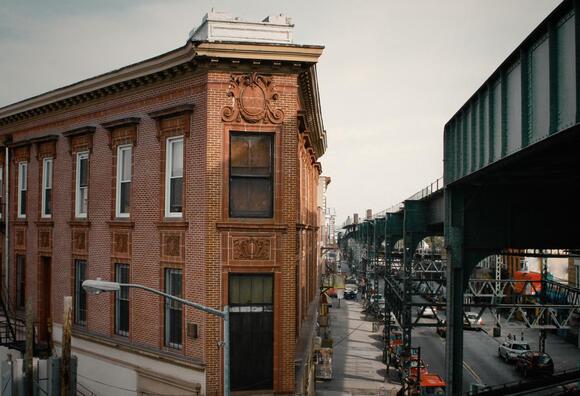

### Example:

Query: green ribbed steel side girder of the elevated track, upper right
xmin=444 ymin=0 xmax=580 ymax=186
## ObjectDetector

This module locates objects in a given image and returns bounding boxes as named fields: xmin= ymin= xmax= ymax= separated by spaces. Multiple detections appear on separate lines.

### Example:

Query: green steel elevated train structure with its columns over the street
xmin=340 ymin=0 xmax=580 ymax=395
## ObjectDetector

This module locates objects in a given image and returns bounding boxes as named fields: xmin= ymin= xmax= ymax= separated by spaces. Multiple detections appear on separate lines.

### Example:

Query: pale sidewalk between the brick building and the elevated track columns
xmin=316 ymin=299 xmax=400 ymax=396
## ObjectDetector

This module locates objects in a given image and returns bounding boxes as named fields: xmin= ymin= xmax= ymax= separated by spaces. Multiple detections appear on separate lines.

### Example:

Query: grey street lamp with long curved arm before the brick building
xmin=83 ymin=278 xmax=230 ymax=396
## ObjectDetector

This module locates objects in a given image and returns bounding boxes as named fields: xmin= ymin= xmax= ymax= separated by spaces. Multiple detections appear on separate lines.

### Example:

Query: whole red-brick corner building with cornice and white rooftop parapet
xmin=0 ymin=12 xmax=326 ymax=395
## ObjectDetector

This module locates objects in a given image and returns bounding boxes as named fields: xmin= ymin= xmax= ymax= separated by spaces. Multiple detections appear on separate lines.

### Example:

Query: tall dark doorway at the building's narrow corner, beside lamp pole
xmin=230 ymin=275 xmax=274 ymax=391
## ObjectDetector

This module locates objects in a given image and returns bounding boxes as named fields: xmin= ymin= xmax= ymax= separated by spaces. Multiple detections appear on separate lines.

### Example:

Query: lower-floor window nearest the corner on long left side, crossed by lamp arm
xmin=165 ymin=268 xmax=183 ymax=349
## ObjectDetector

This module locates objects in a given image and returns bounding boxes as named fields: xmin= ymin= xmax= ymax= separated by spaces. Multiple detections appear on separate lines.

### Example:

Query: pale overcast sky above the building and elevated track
xmin=0 ymin=0 xmax=560 ymax=224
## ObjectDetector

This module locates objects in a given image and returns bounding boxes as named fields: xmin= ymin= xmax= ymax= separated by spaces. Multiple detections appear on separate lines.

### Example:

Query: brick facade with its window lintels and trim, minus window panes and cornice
xmin=0 ymin=37 xmax=324 ymax=395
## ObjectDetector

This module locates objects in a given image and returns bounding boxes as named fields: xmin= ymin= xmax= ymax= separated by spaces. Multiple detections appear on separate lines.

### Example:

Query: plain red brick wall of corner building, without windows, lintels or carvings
xmin=0 ymin=64 xmax=318 ymax=395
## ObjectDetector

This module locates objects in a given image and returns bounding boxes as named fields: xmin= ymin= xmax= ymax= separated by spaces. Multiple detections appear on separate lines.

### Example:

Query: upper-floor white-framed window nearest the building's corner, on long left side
xmin=165 ymin=137 xmax=183 ymax=217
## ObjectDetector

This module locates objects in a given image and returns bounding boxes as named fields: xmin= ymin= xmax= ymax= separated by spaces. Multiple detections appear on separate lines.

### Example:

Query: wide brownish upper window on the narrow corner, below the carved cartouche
xmin=230 ymin=133 xmax=274 ymax=217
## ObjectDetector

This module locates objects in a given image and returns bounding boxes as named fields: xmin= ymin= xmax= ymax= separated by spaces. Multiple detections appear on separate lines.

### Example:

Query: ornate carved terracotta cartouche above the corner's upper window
xmin=221 ymin=73 xmax=284 ymax=124
